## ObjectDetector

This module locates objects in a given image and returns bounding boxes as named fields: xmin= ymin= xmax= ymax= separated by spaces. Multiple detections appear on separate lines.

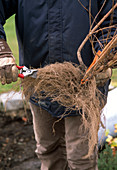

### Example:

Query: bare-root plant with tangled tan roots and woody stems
xmin=22 ymin=0 xmax=117 ymax=157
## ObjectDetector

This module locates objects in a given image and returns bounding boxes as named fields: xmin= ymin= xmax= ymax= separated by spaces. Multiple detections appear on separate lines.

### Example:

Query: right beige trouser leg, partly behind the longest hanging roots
xmin=65 ymin=116 xmax=98 ymax=170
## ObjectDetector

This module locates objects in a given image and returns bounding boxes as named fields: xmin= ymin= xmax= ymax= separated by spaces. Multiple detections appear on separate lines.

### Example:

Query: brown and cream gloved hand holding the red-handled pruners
xmin=0 ymin=39 xmax=18 ymax=85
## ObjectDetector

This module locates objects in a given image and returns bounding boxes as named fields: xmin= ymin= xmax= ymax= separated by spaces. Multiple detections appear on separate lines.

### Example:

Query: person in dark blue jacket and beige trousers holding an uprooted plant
xmin=0 ymin=0 xmax=117 ymax=170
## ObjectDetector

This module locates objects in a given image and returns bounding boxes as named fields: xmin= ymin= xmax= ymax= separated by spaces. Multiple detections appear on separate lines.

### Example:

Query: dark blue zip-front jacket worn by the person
xmin=0 ymin=0 xmax=117 ymax=117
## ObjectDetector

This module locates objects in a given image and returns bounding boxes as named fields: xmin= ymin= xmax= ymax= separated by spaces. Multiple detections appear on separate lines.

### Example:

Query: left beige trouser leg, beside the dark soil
xmin=30 ymin=104 xmax=68 ymax=170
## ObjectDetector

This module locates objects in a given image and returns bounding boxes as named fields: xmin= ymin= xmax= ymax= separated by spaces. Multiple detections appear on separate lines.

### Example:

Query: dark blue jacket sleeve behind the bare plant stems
xmin=95 ymin=0 xmax=117 ymax=51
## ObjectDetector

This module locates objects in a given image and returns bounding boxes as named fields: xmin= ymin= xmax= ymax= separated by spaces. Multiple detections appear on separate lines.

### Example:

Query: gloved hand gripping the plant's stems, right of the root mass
xmin=95 ymin=68 xmax=112 ymax=87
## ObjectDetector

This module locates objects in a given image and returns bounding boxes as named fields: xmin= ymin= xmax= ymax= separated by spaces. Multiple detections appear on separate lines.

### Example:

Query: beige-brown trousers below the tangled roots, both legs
xmin=30 ymin=104 xmax=98 ymax=170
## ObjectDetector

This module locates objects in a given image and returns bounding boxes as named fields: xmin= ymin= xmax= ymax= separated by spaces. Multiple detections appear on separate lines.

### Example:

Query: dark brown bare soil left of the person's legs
xmin=0 ymin=112 xmax=40 ymax=170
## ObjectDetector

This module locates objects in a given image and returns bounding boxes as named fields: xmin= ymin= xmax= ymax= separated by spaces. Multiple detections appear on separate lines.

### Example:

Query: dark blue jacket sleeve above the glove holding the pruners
xmin=0 ymin=0 xmax=17 ymax=39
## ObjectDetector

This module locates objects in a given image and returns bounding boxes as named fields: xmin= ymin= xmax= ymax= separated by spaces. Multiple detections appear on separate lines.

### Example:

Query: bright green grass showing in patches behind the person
xmin=0 ymin=16 xmax=117 ymax=93
